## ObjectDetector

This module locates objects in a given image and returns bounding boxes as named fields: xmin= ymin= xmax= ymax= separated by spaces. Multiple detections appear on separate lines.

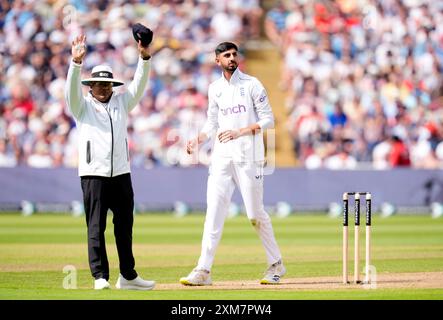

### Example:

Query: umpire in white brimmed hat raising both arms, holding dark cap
xmin=65 ymin=28 xmax=155 ymax=290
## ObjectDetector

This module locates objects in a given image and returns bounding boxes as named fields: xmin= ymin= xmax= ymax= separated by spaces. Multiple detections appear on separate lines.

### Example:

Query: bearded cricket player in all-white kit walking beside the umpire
xmin=180 ymin=42 xmax=286 ymax=285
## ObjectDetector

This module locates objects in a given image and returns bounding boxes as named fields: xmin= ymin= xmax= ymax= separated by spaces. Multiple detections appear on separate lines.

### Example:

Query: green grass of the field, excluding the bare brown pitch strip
xmin=0 ymin=213 xmax=443 ymax=300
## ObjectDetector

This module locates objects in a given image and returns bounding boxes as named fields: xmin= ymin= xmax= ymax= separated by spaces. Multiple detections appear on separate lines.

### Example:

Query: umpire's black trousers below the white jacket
xmin=81 ymin=173 xmax=137 ymax=280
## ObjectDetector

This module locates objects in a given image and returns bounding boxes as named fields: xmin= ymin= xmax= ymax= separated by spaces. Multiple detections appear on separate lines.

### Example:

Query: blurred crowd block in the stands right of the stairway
xmin=265 ymin=0 xmax=443 ymax=169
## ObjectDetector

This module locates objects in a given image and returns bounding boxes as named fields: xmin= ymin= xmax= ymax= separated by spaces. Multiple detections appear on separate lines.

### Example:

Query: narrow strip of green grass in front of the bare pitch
xmin=0 ymin=289 xmax=443 ymax=300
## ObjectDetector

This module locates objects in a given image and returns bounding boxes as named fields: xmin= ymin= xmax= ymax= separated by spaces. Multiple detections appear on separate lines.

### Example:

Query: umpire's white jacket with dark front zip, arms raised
xmin=65 ymin=57 xmax=151 ymax=177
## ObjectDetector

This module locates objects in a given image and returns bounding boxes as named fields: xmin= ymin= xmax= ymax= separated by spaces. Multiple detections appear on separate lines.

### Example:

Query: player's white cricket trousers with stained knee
xmin=197 ymin=159 xmax=281 ymax=271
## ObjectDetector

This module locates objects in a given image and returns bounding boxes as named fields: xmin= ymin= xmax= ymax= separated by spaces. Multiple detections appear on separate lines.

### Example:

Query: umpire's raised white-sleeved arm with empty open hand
xmin=65 ymin=35 xmax=86 ymax=118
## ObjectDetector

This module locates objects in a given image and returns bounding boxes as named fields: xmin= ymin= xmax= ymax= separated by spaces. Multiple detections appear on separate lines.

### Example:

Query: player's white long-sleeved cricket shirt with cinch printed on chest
xmin=201 ymin=68 xmax=274 ymax=162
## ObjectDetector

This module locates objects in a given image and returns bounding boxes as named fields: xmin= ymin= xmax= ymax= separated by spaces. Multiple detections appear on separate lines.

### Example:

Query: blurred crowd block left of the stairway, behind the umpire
xmin=0 ymin=0 xmax=263 ymax=168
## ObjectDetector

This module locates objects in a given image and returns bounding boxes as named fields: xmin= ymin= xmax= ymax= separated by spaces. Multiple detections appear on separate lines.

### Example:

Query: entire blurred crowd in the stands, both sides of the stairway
xmin=0 ymin=0 xmax=443 ymax=169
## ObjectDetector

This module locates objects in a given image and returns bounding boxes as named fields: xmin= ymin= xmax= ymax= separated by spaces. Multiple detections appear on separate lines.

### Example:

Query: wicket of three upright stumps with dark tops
xmin=343 ymin=192 xmax=372 ymax=284
